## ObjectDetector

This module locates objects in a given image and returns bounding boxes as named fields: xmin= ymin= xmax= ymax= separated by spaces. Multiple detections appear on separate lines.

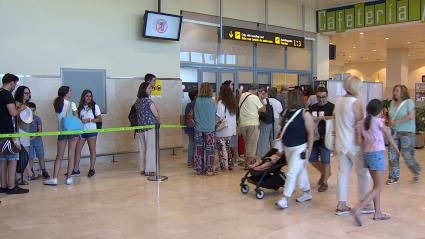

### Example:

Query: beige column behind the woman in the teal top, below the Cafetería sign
xmin=385 ymin=48 xmax=409 ymax=97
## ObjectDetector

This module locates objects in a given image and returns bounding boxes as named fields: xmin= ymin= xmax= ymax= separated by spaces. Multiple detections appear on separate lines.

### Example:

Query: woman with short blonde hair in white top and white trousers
xmin=334 ymin=76 xmax=373 ymax=215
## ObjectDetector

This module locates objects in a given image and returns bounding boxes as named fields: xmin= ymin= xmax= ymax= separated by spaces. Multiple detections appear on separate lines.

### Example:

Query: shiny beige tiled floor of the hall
xmin=0 ymin=150 xmax=425 ymax=239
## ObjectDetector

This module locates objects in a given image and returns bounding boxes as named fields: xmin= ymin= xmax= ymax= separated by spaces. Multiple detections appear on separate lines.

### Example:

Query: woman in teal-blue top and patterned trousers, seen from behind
xmin=193 ymin=83 xmax=215 ymax=176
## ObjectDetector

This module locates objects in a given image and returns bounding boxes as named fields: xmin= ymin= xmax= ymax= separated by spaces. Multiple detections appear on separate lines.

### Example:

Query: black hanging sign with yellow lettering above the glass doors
xmin=223 ymin=26 xmax=304 ymax=48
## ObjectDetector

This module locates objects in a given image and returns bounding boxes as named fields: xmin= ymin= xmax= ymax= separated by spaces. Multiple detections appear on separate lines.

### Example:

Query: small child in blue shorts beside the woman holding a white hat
xmin=27 ymin=102 xmax=50 ymax=179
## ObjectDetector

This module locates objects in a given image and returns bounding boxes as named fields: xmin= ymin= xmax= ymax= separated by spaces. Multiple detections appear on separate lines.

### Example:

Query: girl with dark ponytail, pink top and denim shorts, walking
xmin=353 ymin=99 xmax=400 ymax=226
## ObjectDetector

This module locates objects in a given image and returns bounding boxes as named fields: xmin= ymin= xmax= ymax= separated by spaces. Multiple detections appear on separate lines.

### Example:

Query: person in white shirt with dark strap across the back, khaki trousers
xmin=239 ymin=86 xmax=266 ymax=169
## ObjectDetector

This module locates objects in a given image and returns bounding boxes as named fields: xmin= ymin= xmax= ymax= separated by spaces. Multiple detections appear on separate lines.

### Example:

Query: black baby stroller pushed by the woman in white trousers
xmin=240 ymin=148 xmax=287 ymax=199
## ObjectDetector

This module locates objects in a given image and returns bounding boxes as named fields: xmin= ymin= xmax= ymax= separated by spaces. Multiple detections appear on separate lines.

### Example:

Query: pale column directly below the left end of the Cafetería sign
xmin=313 ymin=34 xmax=330 ymax=80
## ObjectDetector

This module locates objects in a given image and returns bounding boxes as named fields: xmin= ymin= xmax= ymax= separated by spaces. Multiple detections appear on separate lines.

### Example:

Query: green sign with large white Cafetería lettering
xmin=316 ymin=0 xmax=425 ymax=32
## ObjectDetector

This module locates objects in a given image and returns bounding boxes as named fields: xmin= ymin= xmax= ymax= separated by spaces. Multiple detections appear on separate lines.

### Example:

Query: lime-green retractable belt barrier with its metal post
xmin=0 ymin=124 xmax=186 ymax=181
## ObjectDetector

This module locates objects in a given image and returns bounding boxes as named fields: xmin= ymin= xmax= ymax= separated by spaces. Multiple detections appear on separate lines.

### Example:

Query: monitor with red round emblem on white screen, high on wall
xmin=143 ymin=11 xmax=182 ymax=41
